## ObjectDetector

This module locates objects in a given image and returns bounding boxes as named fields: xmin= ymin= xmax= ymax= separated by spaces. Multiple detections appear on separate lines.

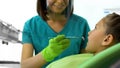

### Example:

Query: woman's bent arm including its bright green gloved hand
xmin=21 ymin=35 xmax=70 ymax=68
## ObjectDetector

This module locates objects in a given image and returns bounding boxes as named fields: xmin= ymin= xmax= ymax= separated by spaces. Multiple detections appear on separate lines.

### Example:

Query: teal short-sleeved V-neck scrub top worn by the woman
xmin=22 ymin=14 xmax=90 ymax=68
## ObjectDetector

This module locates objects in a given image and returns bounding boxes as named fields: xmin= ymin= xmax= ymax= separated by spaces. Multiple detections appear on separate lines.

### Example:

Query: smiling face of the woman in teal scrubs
xmin=47 ymin=0 xmax=69 ymax=13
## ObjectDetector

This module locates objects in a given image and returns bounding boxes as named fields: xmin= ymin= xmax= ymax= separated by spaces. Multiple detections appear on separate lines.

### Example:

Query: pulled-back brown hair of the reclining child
xmin=104 ymin=13 xmax=120 ymax=43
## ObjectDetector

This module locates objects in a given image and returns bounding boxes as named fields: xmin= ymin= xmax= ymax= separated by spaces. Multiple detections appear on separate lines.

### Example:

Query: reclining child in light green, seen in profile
xmin=47 ymin=13 xmax=120 ymax=68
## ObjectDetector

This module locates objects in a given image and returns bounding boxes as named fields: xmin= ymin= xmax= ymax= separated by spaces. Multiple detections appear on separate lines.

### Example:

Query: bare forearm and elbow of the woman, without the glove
xmin=21 ymin=44 xmax=47 ymax=68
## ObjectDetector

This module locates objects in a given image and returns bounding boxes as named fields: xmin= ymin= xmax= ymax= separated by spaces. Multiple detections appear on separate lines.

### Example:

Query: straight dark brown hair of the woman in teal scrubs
xmin=37 ymin=0 xmax=73 ymax=20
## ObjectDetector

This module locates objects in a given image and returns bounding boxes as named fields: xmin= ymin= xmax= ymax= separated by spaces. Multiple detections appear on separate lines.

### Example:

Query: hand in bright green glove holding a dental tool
xmin=41 ymin=35 xmax=70 ymax=62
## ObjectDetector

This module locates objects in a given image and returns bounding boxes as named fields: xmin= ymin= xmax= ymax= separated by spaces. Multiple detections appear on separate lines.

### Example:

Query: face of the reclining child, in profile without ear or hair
xmin=86 ymin=20 xmax=105 ymax=53
